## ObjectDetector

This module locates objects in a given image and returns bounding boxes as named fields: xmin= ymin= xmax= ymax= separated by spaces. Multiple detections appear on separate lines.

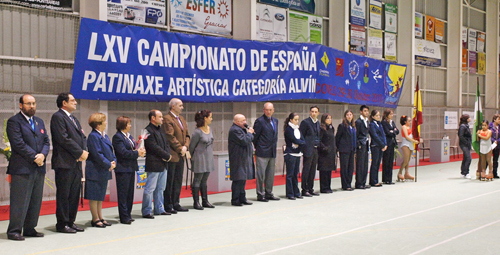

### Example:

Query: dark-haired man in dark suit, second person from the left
xmin=50 ymin=93 xmax=89 ymax=233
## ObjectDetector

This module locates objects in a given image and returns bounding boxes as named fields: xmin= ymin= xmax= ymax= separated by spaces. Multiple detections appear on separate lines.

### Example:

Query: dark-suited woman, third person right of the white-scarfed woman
xmin=335 ymin=110 xmax=356 ymax=191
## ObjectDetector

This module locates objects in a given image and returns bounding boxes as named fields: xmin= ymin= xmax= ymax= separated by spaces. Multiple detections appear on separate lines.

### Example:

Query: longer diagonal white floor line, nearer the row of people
xmin=258 ymin=190 xmax=500 ymax=255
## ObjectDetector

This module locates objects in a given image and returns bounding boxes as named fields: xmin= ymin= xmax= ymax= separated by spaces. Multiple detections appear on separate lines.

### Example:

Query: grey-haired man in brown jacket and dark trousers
xmin=162 ymin=98 xmax=189 ymax=214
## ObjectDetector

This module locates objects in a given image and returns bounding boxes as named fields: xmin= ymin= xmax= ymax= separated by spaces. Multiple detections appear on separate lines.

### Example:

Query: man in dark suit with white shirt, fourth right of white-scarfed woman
xmin=354 ymin=105 xmax=371 ymax=189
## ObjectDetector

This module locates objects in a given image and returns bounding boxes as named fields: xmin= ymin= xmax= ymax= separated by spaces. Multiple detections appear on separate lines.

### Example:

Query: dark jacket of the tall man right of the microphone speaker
xmin=253 ymin=114 xmax=278 ymax=158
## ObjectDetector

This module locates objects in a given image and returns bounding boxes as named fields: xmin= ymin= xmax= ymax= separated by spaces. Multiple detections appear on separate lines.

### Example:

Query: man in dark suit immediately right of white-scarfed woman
xmin=299 ymin=106 xmax=320 ymax=197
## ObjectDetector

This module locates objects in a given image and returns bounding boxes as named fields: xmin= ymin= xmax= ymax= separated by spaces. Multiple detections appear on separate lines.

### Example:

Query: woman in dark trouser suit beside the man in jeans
xmin=113 ymin=116 xmax=146 ymax=224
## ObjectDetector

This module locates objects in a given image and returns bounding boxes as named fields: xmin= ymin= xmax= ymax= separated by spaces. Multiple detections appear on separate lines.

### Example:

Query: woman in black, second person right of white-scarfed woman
xmin=318 ymin=113 xmax=337 ymax=193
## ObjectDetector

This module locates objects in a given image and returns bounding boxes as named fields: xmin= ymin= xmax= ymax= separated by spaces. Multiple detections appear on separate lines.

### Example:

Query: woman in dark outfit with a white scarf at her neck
xmin=283 ymin=112 xmax=306 ymax=200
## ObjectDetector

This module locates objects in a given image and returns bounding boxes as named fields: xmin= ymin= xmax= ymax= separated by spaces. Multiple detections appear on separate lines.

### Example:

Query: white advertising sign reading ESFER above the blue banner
xmin=169 ymin=0 xmax=233 ymax=35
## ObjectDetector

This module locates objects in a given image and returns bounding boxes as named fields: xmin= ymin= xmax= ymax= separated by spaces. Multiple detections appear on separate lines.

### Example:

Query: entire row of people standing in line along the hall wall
xmin=7 ymin=93 xmax=488 ymax=240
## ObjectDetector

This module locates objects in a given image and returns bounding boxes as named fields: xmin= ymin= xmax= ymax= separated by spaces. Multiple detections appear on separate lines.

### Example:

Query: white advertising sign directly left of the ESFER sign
xmin=108 ymin=0 xmax=166 ymax=25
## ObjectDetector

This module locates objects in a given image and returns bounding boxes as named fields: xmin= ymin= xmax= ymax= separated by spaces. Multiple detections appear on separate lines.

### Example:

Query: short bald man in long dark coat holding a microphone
xmin=227 ymin=114 xmax=254 ymax=206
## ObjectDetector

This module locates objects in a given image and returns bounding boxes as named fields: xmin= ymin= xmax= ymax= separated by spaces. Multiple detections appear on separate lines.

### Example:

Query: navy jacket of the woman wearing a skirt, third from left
xmin=85 ymin=129 xmax=116 ymax=181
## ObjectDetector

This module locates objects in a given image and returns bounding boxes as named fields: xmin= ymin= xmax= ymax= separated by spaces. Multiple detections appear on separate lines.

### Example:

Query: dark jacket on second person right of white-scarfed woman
xmin=318 ymin=125 xmax=337 ymax=171
